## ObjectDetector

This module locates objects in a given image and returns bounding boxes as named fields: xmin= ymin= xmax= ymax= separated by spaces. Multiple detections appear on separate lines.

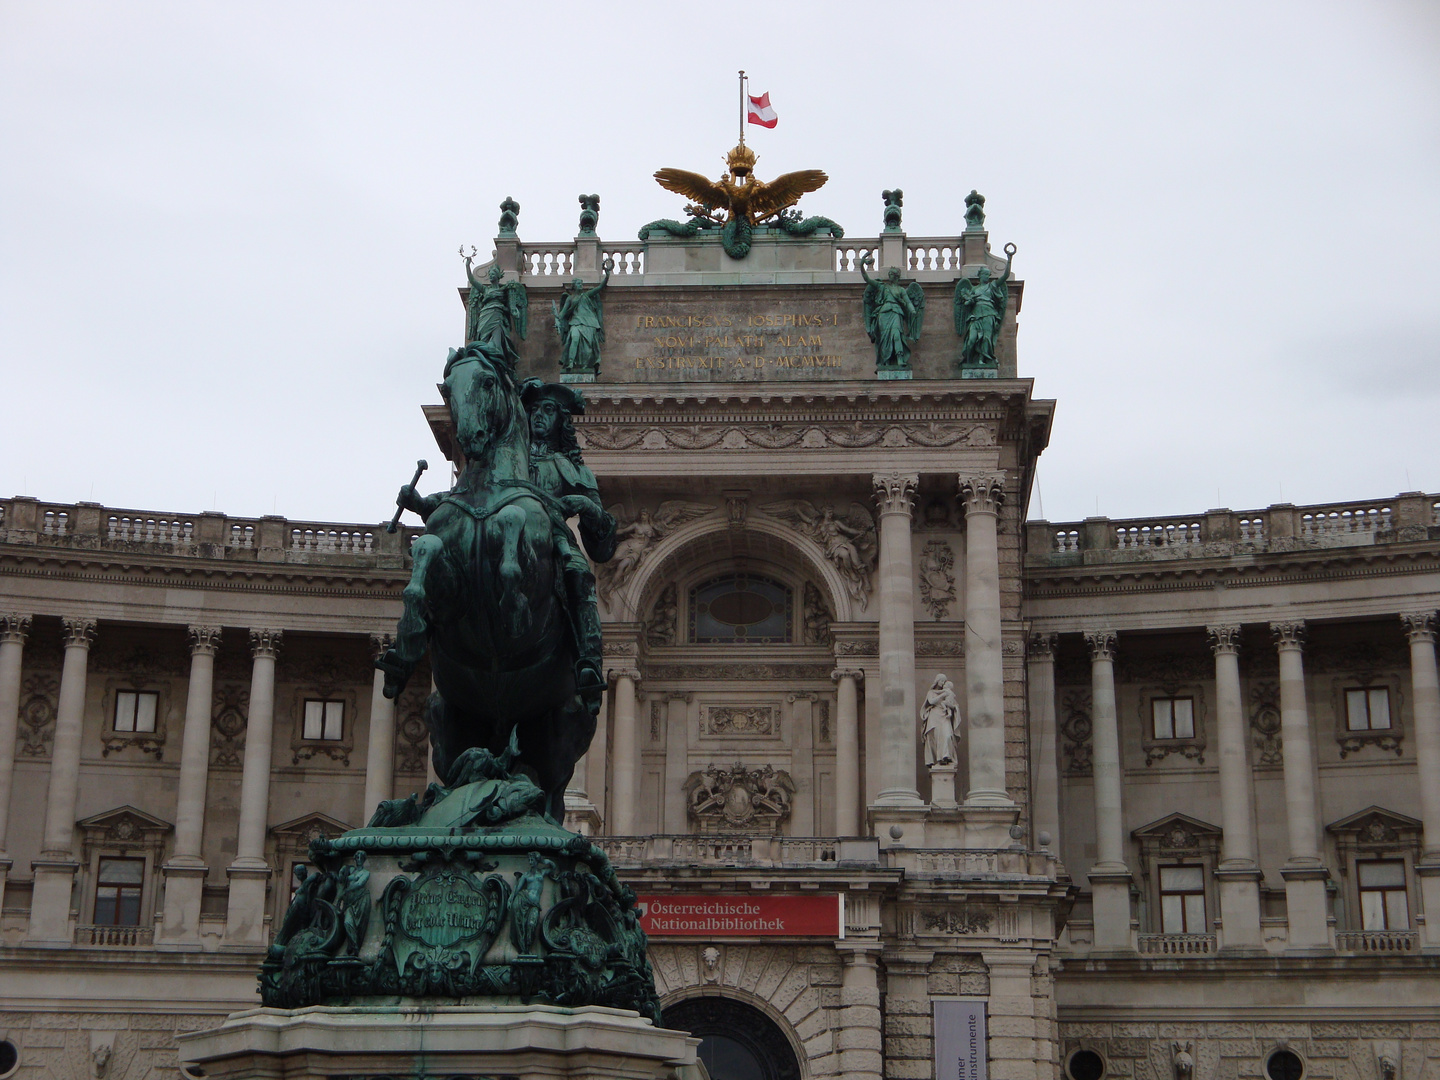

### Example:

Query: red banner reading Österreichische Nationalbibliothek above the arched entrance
xmin=638 ymin=893 xmax=845 ymax=939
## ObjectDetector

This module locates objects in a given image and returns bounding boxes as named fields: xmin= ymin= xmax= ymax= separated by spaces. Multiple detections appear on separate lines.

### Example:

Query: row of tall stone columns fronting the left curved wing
xmin=0 ymin=613 xmax=395 ymax=949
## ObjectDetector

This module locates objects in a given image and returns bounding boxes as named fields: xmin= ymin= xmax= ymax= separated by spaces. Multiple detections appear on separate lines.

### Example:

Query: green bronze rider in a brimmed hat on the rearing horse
xmin=520 ymin=379 xmax=615 ymax=702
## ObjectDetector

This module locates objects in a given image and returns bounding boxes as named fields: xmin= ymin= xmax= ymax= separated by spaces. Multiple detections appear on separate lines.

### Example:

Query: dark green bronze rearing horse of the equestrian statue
xmin=376 ymin=341 xmax=595 ymax=822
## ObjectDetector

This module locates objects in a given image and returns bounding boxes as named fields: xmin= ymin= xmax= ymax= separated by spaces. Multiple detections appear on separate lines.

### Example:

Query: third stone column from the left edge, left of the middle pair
xmin=160 ymin=626 xmax=220 ymax=949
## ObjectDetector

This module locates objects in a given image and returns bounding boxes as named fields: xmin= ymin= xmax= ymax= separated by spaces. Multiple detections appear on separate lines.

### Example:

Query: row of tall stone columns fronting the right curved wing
xmin=1030 ymin=612 xmax=1440 ymax=950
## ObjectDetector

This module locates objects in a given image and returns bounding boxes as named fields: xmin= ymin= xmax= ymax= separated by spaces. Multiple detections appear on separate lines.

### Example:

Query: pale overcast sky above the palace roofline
xmin=0 ymin=0 xmax=1440 ymax=521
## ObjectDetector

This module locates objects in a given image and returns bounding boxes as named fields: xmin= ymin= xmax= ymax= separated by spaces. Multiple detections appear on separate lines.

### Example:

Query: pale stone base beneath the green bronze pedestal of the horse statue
xmin=177 ymin=998 xmax=700 ymax=1080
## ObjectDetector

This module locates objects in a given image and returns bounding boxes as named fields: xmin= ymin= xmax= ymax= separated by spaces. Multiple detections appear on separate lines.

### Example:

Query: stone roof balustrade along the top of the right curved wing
xmin=1027 ymin=491 xmax=1440 ymax=566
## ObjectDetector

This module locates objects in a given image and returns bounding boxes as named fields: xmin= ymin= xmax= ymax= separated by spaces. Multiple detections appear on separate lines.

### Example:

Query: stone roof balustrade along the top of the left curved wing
xmin=0 ymin=497 xmax=422 ymax=567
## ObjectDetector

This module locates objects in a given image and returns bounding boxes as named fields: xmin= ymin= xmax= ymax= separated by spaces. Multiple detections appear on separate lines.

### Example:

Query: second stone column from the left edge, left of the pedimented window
xmin=27 ymin=619 xmax=95 ymax=945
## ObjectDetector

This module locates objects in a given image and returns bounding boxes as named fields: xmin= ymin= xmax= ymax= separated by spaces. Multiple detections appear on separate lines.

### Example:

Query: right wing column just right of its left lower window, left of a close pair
xmin=1205 ymin=626 xmax=1264 ymax=949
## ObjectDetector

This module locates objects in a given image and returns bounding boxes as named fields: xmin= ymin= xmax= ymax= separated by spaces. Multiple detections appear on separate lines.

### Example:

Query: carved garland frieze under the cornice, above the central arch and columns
xmin=576 ymin=420 xmax=995 ymax=451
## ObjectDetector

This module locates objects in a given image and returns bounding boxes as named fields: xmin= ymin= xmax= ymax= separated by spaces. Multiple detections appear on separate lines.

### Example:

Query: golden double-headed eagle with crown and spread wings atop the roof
xmin=639 ymin=143 xmax=845 ymax=259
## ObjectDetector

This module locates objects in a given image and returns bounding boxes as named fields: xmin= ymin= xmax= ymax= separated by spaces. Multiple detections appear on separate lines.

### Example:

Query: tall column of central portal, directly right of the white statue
xmin=959 ymin=472 xmax=1014 ymax=806
